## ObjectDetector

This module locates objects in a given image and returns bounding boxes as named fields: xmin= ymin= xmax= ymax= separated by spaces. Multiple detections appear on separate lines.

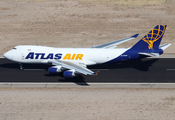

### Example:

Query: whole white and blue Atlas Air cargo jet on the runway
xmin=4 ymin=25 xmax=171 ymax=78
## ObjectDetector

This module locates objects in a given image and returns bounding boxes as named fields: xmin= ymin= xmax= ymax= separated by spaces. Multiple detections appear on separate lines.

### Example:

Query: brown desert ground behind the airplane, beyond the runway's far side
xmin=0 ymin=0 xmax=175 ymax=54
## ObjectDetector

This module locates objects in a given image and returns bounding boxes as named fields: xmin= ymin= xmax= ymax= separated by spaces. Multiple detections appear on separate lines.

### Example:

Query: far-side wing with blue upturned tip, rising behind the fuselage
xmin=91 ymin=34 xmax=139 ymax=49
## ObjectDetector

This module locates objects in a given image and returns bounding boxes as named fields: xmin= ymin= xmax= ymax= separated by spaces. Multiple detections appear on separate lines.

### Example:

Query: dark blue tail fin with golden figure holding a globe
xmin=131 ymin=25 xmax=166 ymax=52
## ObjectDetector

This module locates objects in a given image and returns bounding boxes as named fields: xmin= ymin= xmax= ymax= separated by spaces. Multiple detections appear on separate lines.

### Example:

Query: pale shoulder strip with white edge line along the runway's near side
xmin=0 ymin=82 xmax=175 ymax=89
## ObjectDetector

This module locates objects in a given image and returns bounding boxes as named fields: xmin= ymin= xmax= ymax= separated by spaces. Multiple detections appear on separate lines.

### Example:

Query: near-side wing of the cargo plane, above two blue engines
xmin=50 ymin=60 xmax=97 ymax=75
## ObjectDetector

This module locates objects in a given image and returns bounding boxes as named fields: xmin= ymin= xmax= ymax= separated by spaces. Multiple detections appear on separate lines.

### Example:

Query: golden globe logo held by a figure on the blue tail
xmin=142 ymin=25 xmax=166 ymax=49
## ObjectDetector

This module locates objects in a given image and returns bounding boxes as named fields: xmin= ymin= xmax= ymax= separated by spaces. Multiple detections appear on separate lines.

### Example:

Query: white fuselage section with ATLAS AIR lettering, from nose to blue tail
xmin=4 ymin=45 xmax=128 ymax=66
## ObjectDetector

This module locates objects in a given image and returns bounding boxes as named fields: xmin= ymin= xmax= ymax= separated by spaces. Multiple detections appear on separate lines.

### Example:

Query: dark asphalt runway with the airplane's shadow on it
xmin=0 ymin=58 xmax=175 ymax=84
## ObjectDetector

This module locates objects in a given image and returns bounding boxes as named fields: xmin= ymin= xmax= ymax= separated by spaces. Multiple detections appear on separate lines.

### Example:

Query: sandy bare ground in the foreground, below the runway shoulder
xmin=0 ymin=88 xmax=175 ymax=120
